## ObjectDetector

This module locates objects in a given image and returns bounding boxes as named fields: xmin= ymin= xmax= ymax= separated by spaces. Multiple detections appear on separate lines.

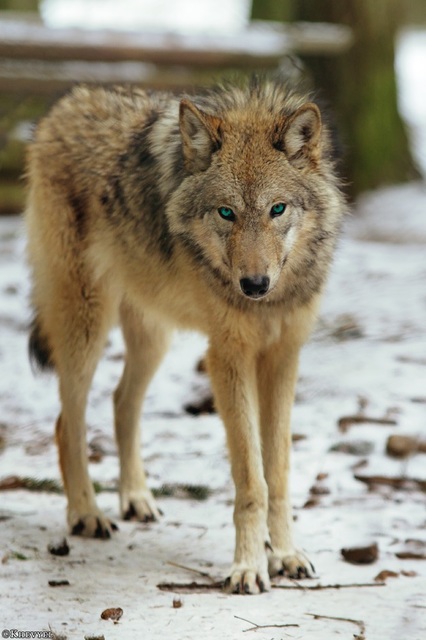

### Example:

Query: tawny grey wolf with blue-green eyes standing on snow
xmin=25 ymin=79 xmax=346 ymax=594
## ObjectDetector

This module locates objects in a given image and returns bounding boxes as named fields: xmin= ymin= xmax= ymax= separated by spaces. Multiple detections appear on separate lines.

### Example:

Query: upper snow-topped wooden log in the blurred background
xmin=0 ymin=20 xmax=351 ymax=69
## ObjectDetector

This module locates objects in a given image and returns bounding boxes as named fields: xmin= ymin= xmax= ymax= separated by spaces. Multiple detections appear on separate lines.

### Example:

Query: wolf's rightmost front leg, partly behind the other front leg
xmin=257 ymin=336 xmax=314 ymax=578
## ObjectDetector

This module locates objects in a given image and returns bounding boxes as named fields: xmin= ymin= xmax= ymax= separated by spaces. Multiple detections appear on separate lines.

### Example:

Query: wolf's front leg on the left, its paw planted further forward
xmin=208 ymin=343 xmax=269 ymax=593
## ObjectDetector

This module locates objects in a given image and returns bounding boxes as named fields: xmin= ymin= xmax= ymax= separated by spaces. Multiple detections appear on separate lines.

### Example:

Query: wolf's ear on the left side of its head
xmin=179 ymin=99 xmax=221 ymax=173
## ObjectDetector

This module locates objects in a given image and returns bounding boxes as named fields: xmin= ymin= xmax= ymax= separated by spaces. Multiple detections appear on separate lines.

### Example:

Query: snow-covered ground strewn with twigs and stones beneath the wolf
xmin=0 ymin=183 xmax=426 ymax=640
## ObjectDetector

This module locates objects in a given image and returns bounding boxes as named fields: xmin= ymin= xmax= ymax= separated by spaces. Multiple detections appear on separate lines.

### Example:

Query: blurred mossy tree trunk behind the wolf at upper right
xmin=252 ymin=0 xmax=424 ymax=196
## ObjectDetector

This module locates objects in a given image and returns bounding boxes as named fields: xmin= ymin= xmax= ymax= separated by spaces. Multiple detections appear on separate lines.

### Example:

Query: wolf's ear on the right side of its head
xmin=274 ymin=102 xmax=322 ymax=169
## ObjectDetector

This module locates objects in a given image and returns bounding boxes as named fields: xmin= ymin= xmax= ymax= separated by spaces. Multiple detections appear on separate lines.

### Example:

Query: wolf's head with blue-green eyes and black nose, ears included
xmin=165 ymin=84 xmax=344 ymax=302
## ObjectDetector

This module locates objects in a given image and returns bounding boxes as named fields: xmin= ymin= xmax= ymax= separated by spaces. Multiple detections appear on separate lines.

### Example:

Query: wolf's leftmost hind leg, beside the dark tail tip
xmin=52 ymin=281 xmax=117 ymax=538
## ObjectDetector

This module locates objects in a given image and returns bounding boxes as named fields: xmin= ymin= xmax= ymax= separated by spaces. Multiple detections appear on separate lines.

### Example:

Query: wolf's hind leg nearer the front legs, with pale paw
xmin=114 ymin=303 xmax=170 ymax=522
